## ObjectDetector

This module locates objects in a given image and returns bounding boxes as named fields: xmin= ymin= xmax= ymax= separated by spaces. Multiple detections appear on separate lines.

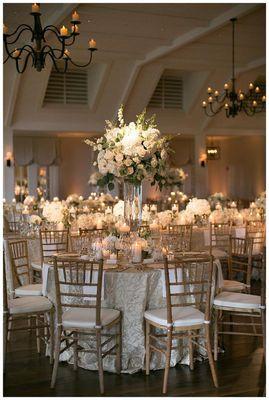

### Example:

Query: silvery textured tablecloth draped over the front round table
xmin=43 ymin=264 xmax=214 ymax=373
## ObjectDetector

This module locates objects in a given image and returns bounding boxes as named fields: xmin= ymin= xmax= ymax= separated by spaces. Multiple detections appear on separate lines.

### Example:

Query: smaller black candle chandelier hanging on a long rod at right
xmin=202 ymin=18 xmax=266 ymax=118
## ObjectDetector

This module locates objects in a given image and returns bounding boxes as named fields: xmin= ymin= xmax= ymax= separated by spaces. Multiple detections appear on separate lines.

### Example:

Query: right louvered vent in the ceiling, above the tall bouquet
xmin=148 ymin=75 xmax=183 ymax=110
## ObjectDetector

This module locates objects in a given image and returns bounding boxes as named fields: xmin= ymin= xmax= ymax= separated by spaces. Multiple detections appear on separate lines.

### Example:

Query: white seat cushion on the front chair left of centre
xmin=62 ymin=308 xmax=120 ymax=329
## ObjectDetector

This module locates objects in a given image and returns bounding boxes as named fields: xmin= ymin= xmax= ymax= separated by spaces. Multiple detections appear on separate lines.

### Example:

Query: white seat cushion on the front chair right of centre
xmin=144 ymin=306 xmax=205 ymax=327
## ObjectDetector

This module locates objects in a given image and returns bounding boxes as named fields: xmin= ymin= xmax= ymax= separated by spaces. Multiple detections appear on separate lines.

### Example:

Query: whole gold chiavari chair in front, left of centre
xmin=51 ymin=256 xmax=121 ymax=394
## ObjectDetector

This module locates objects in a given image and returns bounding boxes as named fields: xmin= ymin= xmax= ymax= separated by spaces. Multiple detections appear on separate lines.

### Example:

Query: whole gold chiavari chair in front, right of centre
xmin=144 ymin=257 xmax=218 ymax=394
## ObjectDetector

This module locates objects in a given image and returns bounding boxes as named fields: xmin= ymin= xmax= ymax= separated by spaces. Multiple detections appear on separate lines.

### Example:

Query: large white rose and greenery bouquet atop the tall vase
xmin=85 ymin=106 xmax=171 ymax=190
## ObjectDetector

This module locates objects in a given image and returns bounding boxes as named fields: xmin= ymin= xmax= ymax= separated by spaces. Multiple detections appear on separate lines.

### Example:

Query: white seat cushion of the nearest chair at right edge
xmin=214 ymin=292 xmax=261 ymax=309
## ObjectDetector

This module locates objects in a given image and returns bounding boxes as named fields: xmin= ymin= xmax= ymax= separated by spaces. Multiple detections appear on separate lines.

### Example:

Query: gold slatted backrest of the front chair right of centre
xmin=164 ymin=256 xmax=213 ymax=323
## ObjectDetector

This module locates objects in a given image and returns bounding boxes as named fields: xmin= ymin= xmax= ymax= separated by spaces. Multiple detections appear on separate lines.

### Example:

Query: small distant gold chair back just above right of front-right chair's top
xmin=209 ymin=223 xmax=232 ymax=260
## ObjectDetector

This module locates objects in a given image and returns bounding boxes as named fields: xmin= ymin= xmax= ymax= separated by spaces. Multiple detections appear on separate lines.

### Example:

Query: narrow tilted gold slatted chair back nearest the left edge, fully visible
xmin=8 ymin=239 xmax=32 ymax=287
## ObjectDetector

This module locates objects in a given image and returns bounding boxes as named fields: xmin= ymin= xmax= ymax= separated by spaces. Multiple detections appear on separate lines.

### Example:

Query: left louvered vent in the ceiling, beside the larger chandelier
xmin=44 ymin=69 xmax=88 ymax=104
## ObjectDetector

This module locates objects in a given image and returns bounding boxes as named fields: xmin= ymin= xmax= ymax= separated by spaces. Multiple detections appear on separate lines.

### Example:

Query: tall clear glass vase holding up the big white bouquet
xmin=123 ymin=181 xmax=142 ymax=231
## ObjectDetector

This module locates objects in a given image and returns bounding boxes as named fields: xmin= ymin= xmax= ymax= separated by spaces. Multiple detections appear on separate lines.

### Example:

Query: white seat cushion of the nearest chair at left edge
xmin=8 ymin=296 xmax=53 ymax=315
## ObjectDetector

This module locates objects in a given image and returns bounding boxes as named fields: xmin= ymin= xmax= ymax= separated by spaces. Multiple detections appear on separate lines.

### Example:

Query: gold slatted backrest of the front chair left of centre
xmin=53 ymin=255 xmax=103 ymax=325
